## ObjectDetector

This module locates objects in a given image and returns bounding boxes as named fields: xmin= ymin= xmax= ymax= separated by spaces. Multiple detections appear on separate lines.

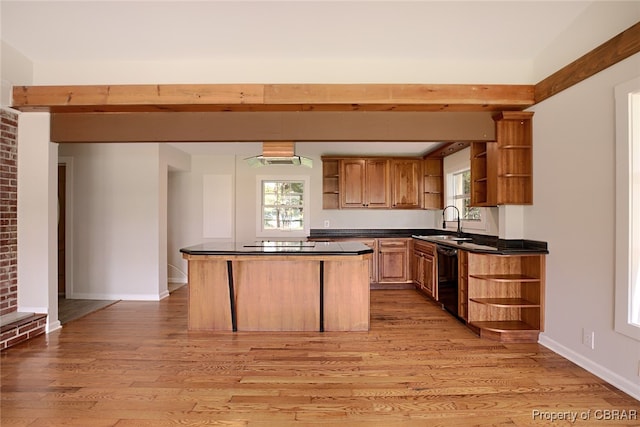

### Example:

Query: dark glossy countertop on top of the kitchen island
xmin=180 ymin=240 xmax=373 ymax=256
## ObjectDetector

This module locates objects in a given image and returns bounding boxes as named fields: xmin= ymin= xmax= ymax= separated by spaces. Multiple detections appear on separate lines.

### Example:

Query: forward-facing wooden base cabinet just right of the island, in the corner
xmin=378 ymin=238 xmax=411 ymax=283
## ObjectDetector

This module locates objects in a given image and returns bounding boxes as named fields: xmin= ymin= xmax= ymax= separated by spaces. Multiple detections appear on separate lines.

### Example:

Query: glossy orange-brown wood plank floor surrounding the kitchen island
xmin=0 ymin=287 xmax=640 ymax=427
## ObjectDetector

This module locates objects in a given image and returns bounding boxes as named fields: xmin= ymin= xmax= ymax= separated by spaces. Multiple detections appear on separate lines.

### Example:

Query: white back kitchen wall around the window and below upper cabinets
xmin=168 ymin=149 xmax=440 ymax=275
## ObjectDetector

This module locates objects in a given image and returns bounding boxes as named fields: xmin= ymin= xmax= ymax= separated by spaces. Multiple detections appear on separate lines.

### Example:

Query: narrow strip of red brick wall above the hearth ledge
xmin=0 ymin=108 xmax=18 ymax=316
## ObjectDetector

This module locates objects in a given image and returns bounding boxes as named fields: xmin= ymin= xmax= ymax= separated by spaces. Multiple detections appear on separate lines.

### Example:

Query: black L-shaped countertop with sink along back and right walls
xmin=309 ymin=228 xmax=549 ymax=255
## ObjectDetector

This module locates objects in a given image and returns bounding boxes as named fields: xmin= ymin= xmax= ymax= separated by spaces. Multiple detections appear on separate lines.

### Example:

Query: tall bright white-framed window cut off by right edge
xmin=615 ymin=77 xmax=640 ymax=341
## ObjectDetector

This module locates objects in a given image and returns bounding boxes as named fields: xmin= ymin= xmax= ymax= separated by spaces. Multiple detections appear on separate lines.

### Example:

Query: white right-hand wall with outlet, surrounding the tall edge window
xmin=524 ymin=54 xmax=640 ymax=399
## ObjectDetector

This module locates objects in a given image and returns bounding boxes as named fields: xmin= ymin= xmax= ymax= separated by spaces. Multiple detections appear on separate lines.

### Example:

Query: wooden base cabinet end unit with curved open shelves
xmin=460 ymin=253 xmax=545 ymax=342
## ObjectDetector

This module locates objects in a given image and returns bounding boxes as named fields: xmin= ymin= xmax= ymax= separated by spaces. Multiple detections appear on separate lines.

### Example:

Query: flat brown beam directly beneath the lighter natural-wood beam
xmin=50 ymin=111 xmax=495 ymax=143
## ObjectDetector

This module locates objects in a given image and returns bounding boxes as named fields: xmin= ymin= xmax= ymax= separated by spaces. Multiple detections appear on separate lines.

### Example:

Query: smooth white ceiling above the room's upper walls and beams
xmin=0 ymin=0 xmax=594 ymax=62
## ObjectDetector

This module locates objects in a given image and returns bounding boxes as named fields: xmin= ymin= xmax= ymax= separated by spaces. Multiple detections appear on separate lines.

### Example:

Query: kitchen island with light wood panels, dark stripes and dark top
xmin=180 ymin=241 xmax=373 ymax=332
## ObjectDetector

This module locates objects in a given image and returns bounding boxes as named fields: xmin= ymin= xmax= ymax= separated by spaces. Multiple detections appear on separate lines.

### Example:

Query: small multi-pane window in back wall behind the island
xmin=258 ymin=177 xmax=309 ymax=237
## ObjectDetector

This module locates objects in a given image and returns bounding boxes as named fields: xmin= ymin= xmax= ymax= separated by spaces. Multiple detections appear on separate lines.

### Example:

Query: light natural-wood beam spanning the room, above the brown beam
xmin=12 ymin=84 xmax=534 ymax=113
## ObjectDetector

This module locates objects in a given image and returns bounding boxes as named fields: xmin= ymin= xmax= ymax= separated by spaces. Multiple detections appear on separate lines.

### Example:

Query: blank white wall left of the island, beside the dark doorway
xmin=60 ymin=144 xmax=166 ymax=300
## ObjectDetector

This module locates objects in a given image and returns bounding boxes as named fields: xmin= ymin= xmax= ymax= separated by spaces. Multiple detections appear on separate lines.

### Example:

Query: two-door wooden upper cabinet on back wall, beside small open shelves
xmin=340 ymin=159 xmax=390 ymax=208
